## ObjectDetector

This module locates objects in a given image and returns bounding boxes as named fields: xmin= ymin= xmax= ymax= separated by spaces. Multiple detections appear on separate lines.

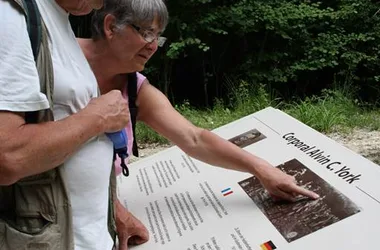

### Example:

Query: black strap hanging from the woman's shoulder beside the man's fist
xmin=128 ymin=73 xmax=139 ymax=157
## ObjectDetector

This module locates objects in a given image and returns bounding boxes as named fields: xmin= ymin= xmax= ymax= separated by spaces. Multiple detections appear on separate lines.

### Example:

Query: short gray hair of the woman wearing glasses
xmin=91 ymin=0 xmax=169 ymax=39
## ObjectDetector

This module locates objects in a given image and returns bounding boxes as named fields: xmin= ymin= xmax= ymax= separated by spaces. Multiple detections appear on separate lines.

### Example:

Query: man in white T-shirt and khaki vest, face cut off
xmin=0 ymin=0 xmax=129 ymax=250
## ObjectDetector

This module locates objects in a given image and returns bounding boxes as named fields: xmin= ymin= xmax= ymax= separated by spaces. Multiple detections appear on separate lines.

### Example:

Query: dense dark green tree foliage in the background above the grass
xmin=73 ymin=0 xmax=380 ymax=105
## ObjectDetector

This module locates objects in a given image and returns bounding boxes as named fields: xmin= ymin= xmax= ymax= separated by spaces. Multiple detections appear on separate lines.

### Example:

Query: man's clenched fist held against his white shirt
xmin=80 ymin=90 xmax=130 ymax=133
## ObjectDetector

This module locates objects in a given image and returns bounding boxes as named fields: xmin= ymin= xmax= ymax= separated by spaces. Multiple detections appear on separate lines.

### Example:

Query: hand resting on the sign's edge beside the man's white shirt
xmin=115 ymin=201 xmax=149 ymax=250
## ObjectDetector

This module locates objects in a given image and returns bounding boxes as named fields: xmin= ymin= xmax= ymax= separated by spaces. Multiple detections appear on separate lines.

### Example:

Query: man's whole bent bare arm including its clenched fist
xmin=0 ymin=90 xmax=129 ymax=185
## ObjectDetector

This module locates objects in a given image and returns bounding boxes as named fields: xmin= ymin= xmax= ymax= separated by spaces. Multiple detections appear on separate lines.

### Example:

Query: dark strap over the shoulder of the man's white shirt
xmin=22 ymin=0 xmax=42 ymax=61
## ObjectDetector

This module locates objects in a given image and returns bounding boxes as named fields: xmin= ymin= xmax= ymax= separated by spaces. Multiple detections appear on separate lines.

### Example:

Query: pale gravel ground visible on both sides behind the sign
xmin=131 ymin=129 xmax=380 ymax=165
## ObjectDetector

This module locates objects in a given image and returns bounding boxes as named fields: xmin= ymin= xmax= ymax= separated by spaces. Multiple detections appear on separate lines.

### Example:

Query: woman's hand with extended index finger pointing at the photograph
xmin=257 ymin=164 xmax=319 ymax=201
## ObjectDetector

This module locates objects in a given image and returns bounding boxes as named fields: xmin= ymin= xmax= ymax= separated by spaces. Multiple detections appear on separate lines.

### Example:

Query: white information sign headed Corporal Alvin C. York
xmin=118 ymin=108 xmax=380 ymax=250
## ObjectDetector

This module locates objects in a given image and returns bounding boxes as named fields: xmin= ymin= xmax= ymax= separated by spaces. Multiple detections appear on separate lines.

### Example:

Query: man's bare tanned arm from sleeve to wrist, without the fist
xmin=0 ymin=112 xmax=103 ymax=185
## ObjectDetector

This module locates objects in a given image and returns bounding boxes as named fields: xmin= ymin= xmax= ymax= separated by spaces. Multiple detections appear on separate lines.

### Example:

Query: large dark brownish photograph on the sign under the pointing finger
xmin=239 ymin=159 xmax=360 ymax=242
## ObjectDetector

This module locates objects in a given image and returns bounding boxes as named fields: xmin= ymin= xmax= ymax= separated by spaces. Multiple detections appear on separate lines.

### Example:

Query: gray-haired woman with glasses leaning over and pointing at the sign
xmin=79 ymin=0 xmax=318 ymax=248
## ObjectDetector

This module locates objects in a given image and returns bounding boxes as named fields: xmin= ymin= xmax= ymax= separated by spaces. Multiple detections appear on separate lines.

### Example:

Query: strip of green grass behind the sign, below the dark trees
xmin=136 ymin=81 xmax=380 ymax=143
